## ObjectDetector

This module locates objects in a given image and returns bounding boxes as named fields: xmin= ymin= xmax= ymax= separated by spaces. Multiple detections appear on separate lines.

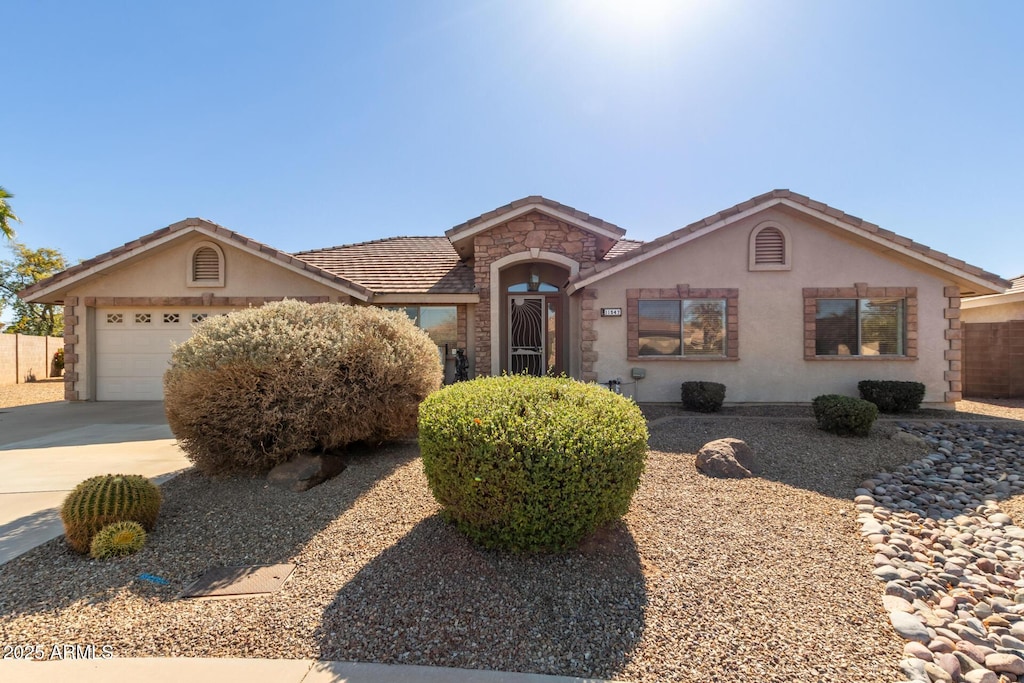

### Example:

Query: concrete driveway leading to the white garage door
xmin=0 ymin=401 xmax=190 ymax=564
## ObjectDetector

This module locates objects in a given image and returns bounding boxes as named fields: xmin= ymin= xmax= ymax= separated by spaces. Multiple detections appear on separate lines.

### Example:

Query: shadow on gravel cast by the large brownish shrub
xmin=0 ymin=443 xmax=418 ymax=618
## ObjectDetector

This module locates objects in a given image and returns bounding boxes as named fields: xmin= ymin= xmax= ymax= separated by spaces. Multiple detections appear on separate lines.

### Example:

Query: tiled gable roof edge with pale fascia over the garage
xmin=18 ymin=218 xmax=370 ymax=298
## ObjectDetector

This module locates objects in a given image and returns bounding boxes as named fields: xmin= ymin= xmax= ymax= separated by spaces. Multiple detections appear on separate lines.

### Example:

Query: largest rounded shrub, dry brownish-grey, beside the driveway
xmin=164 ymin=301 xmax=441 ymax=474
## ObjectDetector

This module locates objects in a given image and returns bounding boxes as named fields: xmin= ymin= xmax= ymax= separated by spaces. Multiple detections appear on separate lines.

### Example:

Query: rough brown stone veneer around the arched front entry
xmin=473 ymin=211 xmax=597 ymax=377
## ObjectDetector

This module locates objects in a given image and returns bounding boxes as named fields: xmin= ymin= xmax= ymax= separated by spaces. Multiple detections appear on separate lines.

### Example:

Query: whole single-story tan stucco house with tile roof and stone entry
xmin=23 ymin=189 xmax=1009 ymax=404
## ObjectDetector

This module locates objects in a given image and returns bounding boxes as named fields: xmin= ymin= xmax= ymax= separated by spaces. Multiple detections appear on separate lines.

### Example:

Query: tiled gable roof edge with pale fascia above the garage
xmin=18 ymin=218 xmax=371 ymax=301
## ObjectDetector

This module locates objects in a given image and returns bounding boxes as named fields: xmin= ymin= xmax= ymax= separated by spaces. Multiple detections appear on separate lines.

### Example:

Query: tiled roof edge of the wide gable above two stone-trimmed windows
xmin=568 ymin=189 xmax=1010 ymax=294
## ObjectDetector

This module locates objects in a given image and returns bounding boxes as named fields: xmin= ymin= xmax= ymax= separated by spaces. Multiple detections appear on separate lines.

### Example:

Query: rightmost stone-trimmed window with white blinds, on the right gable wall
xmin=814 ymin=298 xmax=906 ymax=355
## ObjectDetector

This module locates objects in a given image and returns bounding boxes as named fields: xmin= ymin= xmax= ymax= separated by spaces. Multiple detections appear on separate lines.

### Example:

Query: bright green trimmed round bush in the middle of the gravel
xmin=419 ymin=376 xmax=647 ymax=552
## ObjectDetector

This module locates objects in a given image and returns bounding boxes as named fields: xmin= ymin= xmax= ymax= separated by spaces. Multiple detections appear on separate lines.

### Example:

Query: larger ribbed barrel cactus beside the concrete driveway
xmin=60 ymin=474 xmax=162 ymax=553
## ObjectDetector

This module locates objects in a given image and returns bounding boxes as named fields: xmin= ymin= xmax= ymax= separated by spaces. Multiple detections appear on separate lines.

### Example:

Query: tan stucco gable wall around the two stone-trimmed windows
xmin=593 ymin=209 xmax=949 ymax=403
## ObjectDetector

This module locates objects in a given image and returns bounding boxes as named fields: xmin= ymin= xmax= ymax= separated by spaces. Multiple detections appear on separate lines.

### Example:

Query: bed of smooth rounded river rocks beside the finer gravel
xmin=854 ymin=423 xmax=1024 ymax=683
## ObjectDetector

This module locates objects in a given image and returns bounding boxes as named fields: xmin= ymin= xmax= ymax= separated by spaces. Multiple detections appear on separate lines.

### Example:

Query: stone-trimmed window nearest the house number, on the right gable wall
xmin=638 ymin=299 xmax=727 ymax=356
